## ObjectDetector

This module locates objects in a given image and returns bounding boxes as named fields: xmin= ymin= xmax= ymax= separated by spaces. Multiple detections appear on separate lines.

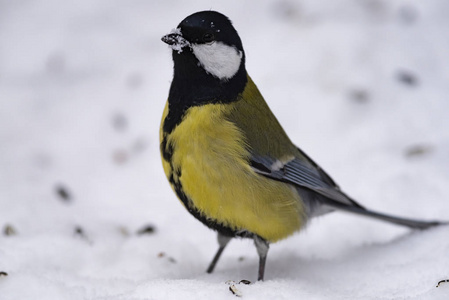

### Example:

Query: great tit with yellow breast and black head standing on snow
xmin=160 ymin=11 xmax=442 ymax=280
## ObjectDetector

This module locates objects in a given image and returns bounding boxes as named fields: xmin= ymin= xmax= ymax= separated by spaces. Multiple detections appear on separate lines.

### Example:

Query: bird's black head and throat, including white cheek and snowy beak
xmin=162 ymin=11 xmax=247 ymax=132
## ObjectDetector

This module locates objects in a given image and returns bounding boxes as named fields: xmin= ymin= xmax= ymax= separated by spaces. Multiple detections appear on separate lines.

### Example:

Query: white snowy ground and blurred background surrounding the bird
xmin=0 ymin=0 xmax=449 ymax=300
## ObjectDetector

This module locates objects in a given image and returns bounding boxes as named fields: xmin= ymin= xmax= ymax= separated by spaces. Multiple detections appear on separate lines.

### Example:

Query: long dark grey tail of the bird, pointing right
xmin=325 ymin=201 xmax=449 ymax=230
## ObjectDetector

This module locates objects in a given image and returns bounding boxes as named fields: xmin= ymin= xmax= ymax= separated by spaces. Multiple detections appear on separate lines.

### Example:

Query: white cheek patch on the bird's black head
xmin=191 ymin=42 xmax=243 ymax=80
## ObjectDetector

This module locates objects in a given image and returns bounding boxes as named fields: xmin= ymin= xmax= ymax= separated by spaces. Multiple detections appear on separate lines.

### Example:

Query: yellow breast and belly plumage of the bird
xmin=161 ymin=104 xmax=305 ymax=242
